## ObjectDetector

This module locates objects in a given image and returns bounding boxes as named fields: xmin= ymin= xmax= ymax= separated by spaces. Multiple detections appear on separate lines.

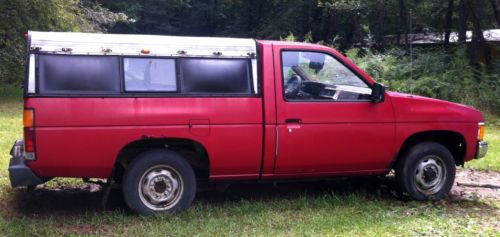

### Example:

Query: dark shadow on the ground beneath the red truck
xmin=6 ymin=176 xmax=492 ymax=218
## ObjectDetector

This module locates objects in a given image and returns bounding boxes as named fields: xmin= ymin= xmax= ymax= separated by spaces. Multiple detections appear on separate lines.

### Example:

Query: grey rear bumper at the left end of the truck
xmin=9 ymin=140 xmax=43 ymax=188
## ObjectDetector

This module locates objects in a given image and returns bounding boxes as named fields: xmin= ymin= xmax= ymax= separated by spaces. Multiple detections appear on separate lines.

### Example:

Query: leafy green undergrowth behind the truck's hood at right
xmin=346 ymin=48 xmax=500 ymax=114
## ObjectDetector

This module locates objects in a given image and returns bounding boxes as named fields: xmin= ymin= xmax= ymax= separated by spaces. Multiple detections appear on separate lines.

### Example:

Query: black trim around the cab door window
xmin=279 ymin=48 xmax=373 ymax=103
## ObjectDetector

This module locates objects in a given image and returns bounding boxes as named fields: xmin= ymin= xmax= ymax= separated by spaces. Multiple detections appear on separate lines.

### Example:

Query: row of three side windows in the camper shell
xmin=33 ymin=54 xmax=257 ymax=97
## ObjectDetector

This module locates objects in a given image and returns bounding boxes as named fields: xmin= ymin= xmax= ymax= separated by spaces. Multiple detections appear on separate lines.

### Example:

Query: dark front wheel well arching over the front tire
xmin=391 ymin=131 xmax=466 ymax=168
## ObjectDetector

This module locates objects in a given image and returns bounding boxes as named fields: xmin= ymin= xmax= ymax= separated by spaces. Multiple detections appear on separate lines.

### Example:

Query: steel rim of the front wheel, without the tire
xmin=415 ymin=155 xmax=447 ymax=195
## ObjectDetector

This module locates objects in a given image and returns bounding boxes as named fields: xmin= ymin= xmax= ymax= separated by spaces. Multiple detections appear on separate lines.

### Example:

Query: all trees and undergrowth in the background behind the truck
xmin=0 ymin=0 xmax=500 ymax=114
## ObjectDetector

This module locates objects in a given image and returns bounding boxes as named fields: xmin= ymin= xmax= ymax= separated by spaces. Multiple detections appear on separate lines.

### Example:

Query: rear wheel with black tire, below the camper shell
xmin=122 ymin=150 xmax=196 ymax=215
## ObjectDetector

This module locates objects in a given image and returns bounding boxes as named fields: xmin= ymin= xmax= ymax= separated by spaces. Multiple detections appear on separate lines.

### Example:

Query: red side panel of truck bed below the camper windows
xmin=26 ymin=98 xmax=262 ymax=177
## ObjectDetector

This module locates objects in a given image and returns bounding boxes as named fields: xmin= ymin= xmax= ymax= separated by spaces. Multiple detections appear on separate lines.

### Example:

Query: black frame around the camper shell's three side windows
xmin=28 ymin=52 xmax=262 ymax=98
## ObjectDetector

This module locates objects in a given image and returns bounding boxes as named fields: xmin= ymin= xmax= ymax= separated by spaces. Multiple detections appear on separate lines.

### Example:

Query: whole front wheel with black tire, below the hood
xmin=396 ymin=142 xmax=456 ymax=201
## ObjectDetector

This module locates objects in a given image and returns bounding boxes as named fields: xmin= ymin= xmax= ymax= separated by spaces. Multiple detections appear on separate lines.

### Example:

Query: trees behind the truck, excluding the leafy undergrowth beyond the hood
xmin=0 ymin=0 xmax=500 ymax=102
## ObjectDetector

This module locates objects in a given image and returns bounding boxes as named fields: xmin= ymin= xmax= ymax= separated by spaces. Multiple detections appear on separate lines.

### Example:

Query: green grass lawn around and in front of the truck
xmin=0 ymin=88 xmax=500 ymax=236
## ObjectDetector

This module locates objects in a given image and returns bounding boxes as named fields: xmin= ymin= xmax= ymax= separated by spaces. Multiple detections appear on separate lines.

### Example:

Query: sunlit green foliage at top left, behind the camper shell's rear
xmin=0 ymin=0 xmax=99 ymax=86
